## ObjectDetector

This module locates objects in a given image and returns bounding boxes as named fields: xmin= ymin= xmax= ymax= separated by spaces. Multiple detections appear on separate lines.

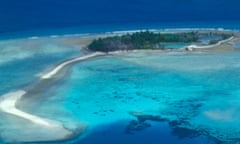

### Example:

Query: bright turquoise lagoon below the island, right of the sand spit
xmin=13 ymin=52 xmax=240 ymax=143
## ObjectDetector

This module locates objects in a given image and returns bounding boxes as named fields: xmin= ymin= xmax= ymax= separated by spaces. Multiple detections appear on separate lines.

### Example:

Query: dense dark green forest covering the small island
xmin=88 ymin=31 xmax=231 ymax=52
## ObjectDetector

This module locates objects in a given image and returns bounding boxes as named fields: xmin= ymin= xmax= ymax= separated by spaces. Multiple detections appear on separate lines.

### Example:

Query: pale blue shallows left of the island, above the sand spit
xmin=0 ymin=38 xmax=82 ymax=95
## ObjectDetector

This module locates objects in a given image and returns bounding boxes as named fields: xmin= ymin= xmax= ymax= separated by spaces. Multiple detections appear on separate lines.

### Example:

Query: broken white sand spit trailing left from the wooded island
xmin=0 ymin=52 xmax=105 ymax=140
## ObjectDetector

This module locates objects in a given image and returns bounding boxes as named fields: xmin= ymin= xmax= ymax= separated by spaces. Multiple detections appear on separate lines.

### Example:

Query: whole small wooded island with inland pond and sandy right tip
xmin=87 ymin=30 xmax=233 ymax=52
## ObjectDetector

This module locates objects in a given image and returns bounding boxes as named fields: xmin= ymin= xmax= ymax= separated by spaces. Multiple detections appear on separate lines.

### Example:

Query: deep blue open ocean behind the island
xmin=0 ymin=0 xmax=240 ymax=38
